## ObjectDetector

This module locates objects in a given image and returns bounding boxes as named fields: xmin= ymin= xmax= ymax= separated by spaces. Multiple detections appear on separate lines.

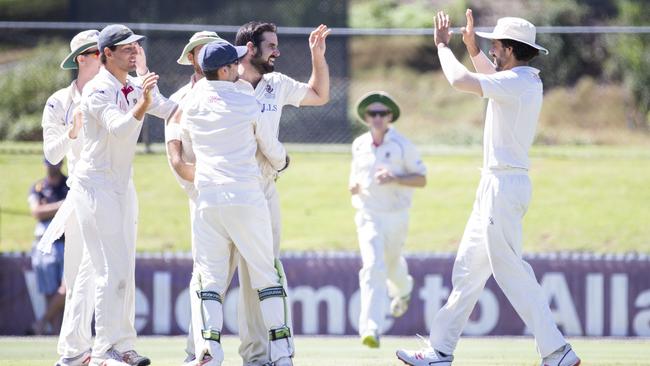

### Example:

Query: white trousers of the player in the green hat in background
xmin=354 ymin=210 xmax=413 ymax=335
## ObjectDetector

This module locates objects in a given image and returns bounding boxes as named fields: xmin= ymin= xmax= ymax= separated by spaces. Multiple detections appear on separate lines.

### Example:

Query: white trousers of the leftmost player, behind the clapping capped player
xmin=57 ymin=212 xmax=95 ymax=358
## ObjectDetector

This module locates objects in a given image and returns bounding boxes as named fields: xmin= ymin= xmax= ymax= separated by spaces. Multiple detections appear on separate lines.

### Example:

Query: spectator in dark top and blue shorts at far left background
xmin=28 ymin=160 xmax=69 ymax=335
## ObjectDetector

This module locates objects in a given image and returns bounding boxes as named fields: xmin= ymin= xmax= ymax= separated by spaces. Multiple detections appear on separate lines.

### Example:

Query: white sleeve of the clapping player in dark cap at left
xmin=81 ymin=89 xmax=142 ymax=138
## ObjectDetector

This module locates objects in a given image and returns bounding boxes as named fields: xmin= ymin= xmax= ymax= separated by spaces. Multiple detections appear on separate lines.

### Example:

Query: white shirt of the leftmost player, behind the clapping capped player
xmin=41 ymin=80 xmax=83 ymax=175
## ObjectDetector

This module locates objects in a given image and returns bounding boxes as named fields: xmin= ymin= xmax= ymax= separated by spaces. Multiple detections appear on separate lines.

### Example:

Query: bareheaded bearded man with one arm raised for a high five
xmin=181 ymin=21 xmax=330 ymax=366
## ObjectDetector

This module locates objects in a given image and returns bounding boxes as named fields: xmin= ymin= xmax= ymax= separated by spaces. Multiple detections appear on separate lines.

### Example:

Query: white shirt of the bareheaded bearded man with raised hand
xmin=248 ymin=72 xmax=309 ymax=180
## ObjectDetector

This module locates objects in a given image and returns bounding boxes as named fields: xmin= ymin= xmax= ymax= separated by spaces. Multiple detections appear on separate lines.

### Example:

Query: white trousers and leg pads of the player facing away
xmin=192 ymin=190 xmax=293 ymax=364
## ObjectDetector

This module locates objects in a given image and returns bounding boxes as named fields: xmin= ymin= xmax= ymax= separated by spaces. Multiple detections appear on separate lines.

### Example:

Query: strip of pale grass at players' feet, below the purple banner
xmin=0 ymin=336 xmax=650 ymax=366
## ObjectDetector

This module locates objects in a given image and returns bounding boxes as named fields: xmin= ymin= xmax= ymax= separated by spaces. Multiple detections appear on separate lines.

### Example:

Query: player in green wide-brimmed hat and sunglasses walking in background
xmin=348 ymin=91 xmax=427 ymax=348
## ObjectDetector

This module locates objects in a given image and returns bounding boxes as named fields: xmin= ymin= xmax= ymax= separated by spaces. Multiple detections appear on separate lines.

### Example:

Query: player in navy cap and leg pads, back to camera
xmin=175 ymin=41 xmax=293 ymax=366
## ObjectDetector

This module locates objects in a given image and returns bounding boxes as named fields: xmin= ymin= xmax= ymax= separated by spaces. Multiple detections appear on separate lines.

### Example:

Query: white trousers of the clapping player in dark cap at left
xmin=72 ymin=182 xmax=138 ymax=359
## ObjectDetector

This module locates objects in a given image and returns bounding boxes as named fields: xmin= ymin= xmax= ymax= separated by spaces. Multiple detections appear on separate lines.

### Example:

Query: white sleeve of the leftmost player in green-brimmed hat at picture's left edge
xmin=41 ymin=96 xmax=72 ymax=164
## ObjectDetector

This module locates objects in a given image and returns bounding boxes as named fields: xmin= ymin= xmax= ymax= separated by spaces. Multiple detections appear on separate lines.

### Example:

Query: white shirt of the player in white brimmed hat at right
xmin=479 ymin=66 xmax=543 ymax=170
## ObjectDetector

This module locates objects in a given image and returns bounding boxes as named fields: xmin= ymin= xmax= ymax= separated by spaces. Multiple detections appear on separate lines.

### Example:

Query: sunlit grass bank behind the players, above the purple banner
xmin=0 ymin=144 xmax=650 ymax=253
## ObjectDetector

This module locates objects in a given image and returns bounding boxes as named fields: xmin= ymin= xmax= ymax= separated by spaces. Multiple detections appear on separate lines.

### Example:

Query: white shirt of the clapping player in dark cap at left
xmin=75 ymin=67 xmax=176 ymax=193
